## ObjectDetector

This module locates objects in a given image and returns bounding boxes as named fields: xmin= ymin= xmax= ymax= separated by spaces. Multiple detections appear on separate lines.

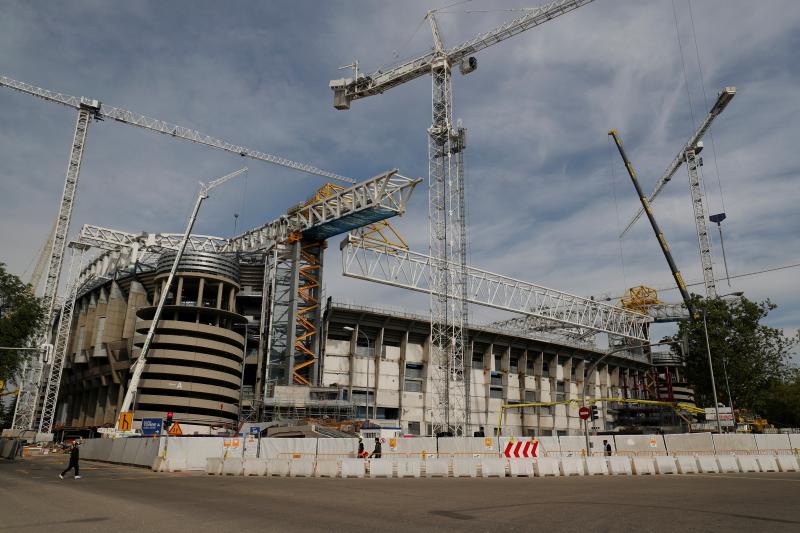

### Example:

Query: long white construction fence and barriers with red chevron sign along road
xmin=69 ymin=433 xmax=800 ymax=475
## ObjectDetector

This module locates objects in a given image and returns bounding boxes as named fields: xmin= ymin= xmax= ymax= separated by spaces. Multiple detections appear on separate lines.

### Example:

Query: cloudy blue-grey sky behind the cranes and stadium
xmin=0 ymin=0 xmax=800 ymax=354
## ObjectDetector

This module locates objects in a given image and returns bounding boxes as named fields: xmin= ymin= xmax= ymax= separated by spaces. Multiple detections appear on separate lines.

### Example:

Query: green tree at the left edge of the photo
xmin=0 ymin=263 xmax=45 ymax=381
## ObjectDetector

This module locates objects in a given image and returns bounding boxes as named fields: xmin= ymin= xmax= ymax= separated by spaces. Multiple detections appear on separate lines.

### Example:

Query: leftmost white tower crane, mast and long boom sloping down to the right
xmin=0 ymin=76 xmax=355 ymax=430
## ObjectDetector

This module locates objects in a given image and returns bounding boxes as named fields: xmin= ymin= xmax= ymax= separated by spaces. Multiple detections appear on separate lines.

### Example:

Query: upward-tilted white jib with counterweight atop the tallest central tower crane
xmin=331 ymin=0 xmax=593 ymax=109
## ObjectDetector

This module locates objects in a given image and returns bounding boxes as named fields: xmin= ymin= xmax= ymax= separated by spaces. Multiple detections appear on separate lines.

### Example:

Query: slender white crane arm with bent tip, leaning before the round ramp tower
xmin=119 ymin=167 xmax=247 ymax=424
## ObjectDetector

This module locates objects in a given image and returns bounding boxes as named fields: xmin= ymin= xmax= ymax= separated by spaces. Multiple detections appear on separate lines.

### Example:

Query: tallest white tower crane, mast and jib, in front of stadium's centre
xmin=330 ymin=0 xmax=592 ymax=435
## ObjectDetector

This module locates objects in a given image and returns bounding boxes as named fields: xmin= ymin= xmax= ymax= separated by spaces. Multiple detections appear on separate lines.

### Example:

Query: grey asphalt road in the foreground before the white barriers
xmin=0 ymin=457 xmax=800 ymax=533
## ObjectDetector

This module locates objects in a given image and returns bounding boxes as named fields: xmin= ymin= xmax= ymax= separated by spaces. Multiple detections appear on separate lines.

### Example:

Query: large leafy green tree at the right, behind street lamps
xmin=673 ymin=295 xmax=797 ymax=414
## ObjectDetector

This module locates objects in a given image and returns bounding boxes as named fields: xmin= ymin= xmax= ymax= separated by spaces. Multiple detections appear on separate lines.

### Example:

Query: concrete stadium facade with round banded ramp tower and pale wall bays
xmin=55 ymin=252 xmax=652 ymax=436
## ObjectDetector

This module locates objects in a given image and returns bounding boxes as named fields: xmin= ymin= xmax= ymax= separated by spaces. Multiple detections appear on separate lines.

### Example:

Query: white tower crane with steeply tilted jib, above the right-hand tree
xmin=620 ymin=87 xmax=736 ymax=298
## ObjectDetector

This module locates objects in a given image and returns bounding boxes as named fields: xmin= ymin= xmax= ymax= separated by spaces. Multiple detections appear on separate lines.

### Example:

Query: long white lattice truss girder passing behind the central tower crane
xmin=342 ymin=235 xmax=653 ymax=341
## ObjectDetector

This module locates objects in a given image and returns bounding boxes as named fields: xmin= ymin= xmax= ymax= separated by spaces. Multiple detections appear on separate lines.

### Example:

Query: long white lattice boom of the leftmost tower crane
xmin=0 ymin=76 xmax=355 ymax=183
